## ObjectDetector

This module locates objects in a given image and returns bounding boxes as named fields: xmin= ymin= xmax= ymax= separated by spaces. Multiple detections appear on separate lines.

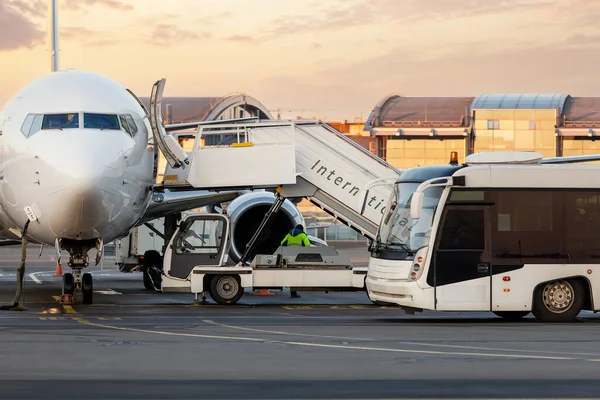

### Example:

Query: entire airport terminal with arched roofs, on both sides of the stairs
xmin=146 ymin=93 xmax=600 ymax=240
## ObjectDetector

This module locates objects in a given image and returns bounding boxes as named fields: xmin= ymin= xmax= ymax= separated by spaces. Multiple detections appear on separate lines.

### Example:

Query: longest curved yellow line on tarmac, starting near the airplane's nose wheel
xmin=72 ymin=318 xmax=590 ymax=361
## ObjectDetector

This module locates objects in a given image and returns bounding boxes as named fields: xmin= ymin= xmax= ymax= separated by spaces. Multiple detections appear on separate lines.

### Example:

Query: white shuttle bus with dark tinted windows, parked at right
xmin=366 ymin=152 xmax=600 ymax=321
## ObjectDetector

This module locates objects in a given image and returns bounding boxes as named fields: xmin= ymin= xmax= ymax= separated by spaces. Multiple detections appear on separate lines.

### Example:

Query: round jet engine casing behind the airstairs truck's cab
xmin=227 ymin=192 xmax=304 ymax=263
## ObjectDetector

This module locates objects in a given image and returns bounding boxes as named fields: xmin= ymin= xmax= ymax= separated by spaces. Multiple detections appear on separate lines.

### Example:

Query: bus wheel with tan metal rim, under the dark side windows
xmin=532 ymin=279 xmax=585 ymax=322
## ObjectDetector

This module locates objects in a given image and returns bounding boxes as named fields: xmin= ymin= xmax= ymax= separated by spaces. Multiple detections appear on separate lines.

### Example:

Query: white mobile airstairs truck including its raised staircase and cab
xmin=144 ymin=80 xmax=400 ymax=304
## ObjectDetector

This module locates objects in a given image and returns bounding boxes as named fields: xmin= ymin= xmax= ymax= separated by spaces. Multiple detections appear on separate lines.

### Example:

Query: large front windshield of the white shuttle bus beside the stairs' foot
xmin=376 ymin=182 xmax=444 ymax=254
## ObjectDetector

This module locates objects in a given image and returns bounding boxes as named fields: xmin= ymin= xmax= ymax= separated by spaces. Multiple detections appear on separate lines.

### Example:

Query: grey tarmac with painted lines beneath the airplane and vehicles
xmin=0 ymin=242 xmax=600 ymax=399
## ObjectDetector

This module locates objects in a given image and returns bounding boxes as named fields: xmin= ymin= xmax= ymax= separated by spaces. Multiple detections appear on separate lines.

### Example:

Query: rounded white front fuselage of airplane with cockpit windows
xmin=0 ymin=70 xmax=154 ymax=245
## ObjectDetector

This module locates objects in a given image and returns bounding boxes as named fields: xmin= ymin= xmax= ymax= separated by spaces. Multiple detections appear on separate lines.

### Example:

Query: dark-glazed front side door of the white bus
xmin=428 ymin=205 xmax=492 ymax=311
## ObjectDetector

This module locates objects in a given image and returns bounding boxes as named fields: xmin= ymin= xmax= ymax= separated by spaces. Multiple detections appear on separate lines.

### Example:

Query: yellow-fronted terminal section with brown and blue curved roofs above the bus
xmin=364 ymin=93 xmax=600 ymax=168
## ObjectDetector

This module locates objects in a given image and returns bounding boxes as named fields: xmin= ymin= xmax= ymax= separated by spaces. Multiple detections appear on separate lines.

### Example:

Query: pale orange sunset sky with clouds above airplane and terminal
xmin=0 ymin=0 xmax=600 ymax=119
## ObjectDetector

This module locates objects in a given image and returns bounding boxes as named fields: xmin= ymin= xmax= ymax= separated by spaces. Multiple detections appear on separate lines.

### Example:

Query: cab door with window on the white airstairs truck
xmin=169 ymin=214 xmax=229 ymax=279
